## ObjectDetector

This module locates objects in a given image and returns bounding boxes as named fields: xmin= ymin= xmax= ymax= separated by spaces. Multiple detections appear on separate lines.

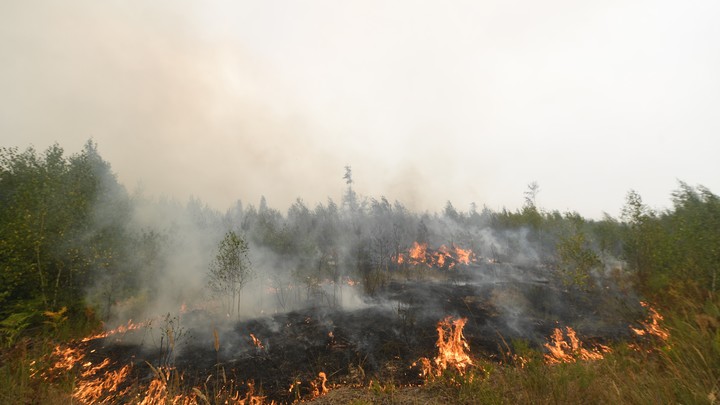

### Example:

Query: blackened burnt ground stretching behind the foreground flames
xmin=81 ymin=265 xmax=642 ymax=402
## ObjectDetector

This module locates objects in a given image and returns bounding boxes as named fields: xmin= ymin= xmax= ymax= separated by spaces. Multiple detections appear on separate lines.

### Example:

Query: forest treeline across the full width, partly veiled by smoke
xmin=0 ymin=141 xmax=720 ymax=345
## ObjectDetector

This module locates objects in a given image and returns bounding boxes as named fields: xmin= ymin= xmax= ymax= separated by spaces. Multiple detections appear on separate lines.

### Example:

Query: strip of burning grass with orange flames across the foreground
xmin=0 ymin=278 xmax=720 ymax=404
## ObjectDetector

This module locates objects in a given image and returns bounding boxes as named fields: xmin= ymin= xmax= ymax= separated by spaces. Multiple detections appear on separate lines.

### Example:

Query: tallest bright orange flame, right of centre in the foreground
xmin=413 ymin=316 xmax=473 ymax=378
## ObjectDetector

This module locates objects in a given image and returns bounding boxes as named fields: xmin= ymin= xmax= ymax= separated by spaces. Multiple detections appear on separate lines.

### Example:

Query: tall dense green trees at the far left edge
xmin=0 ymin=142 xmax=134 ymax=336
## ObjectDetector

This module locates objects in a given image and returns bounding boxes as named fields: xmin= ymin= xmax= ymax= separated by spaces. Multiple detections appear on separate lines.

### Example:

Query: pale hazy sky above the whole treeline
xmin=0 ymin=0 xmax=720 ymax=217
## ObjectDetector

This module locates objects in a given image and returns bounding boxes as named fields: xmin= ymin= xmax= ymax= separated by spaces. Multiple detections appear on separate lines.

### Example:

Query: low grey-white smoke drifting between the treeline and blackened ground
xmin=88 ymin=175 xmax=635 ymax=350
